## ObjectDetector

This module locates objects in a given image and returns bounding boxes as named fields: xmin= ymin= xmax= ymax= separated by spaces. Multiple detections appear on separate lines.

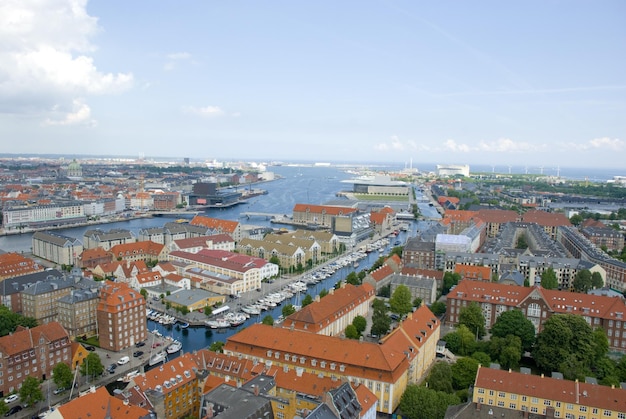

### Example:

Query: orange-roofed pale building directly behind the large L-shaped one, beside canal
xmin=282 ymin=282 xmax=376 ymax=336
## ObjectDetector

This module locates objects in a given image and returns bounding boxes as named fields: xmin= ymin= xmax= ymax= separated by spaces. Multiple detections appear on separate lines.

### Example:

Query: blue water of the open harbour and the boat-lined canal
xmin=0 ymin=166 xmax=437 ymax=356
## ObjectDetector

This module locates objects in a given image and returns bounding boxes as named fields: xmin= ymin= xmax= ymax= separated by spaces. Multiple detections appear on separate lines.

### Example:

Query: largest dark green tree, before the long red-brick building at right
xmin=533 ymin=314 xmax=597 ymax=379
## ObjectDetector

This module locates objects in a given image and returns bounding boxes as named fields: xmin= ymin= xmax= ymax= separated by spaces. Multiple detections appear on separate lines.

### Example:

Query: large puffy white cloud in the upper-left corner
xmin=0 ymin=0 xmax=133 ymax=121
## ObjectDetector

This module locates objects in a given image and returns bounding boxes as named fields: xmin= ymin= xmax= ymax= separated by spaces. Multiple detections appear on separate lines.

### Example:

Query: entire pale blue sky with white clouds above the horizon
xmin=0 ymin=0 xmax=626 ymax=171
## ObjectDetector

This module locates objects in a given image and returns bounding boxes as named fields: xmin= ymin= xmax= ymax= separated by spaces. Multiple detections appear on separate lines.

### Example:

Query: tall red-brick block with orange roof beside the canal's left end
xmin=96 ymin=282 xmax=148 ymax=352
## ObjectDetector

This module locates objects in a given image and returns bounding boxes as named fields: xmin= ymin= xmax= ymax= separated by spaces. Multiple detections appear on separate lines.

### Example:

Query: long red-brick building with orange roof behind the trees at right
xmin=446 ymin=280 xmax=626 ymax=351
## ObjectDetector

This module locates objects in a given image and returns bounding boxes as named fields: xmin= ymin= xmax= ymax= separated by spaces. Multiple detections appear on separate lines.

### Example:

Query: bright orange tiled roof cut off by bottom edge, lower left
xmin=58 ymin=387 xmax=150 ymax=419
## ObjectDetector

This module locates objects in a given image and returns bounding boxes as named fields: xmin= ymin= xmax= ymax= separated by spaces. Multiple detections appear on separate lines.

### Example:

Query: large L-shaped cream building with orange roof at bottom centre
xmin=224 ymin=305 xmax=440 ymax=414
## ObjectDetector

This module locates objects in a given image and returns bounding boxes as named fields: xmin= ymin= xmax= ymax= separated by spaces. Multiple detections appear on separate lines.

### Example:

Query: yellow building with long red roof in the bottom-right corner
xmin=472 ymin=367 xmax=626 ymax=419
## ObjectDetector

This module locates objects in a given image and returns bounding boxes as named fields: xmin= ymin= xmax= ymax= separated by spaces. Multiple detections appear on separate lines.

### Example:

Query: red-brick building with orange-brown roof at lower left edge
xmin=0 ymin=322 xmax=72 ymax=397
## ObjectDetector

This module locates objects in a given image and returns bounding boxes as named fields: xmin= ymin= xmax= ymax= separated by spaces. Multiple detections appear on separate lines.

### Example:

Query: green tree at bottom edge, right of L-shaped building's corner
xmin=398 ymin=384 xmax=461 ymax=419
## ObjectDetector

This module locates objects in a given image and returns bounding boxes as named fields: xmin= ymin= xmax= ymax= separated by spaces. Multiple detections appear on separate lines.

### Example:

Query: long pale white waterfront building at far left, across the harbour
xmin=2 ymin=201 xmax=87 ymax=231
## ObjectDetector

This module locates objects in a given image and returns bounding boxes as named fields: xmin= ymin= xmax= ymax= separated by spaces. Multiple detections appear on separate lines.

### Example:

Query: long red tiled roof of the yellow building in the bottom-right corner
xmin=474 ymin=367 xmax=626 ymax=412
